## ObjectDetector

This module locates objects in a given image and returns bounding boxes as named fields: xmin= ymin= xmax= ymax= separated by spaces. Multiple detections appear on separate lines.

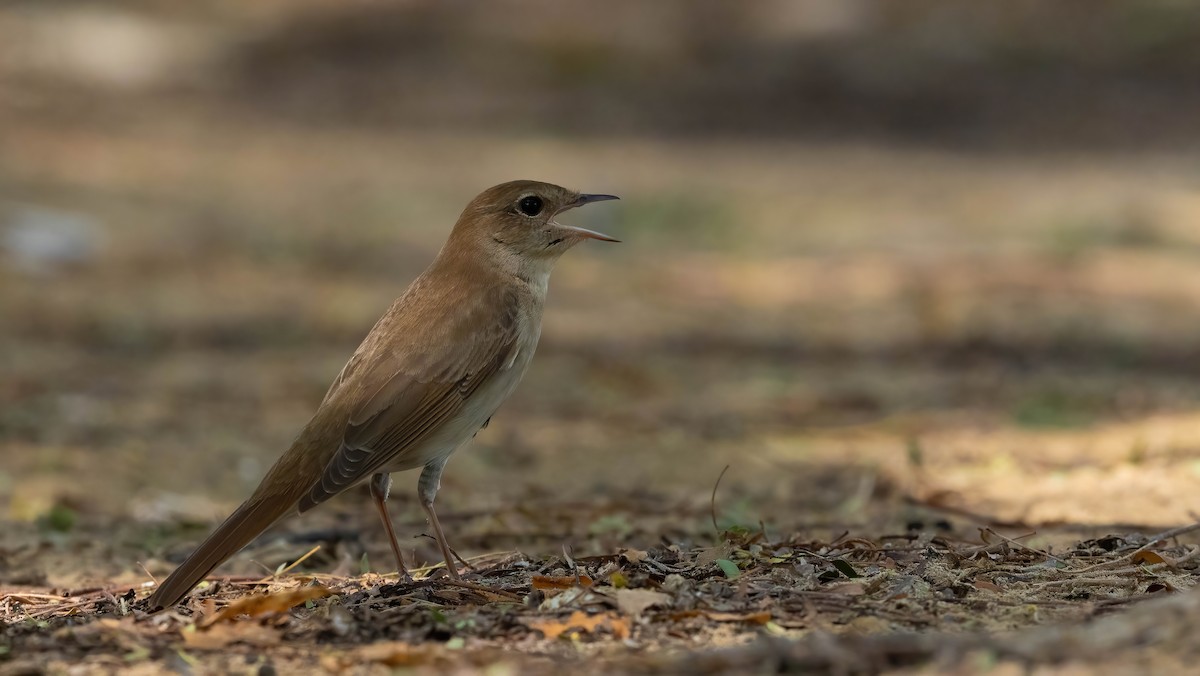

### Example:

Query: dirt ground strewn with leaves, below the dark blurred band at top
xmin=7 ymin=2 xmax=1200 ymax=675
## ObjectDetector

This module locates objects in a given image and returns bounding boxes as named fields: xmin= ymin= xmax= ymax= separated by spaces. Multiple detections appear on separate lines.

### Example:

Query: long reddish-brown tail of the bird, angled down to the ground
xmin=150 ymin=496 xmax=295 ymax=612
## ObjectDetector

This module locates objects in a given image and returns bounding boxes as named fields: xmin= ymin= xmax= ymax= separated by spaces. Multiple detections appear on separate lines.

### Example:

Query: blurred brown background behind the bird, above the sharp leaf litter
xmin=0 ymin=0 xmax=1200 ymax=585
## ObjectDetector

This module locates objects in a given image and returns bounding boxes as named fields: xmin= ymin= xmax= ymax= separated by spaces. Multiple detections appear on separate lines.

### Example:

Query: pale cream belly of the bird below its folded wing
xmin=382 ymin=349 xmax=533 ymax=473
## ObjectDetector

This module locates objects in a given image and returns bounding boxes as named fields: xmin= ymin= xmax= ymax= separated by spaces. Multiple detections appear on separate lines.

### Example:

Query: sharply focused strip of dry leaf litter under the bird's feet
xmin=0 ymin=516 xmax=1200 ymax=672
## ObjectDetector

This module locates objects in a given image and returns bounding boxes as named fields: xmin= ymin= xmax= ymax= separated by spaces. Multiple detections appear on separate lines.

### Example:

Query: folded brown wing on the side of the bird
xmin=299 ymin=286 xmax=520 ymax=513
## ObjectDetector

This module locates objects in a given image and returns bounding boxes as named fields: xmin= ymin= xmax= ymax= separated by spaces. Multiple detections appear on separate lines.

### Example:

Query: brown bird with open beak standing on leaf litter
xmin=149 ymin=180 xmax=618 ymax=611
